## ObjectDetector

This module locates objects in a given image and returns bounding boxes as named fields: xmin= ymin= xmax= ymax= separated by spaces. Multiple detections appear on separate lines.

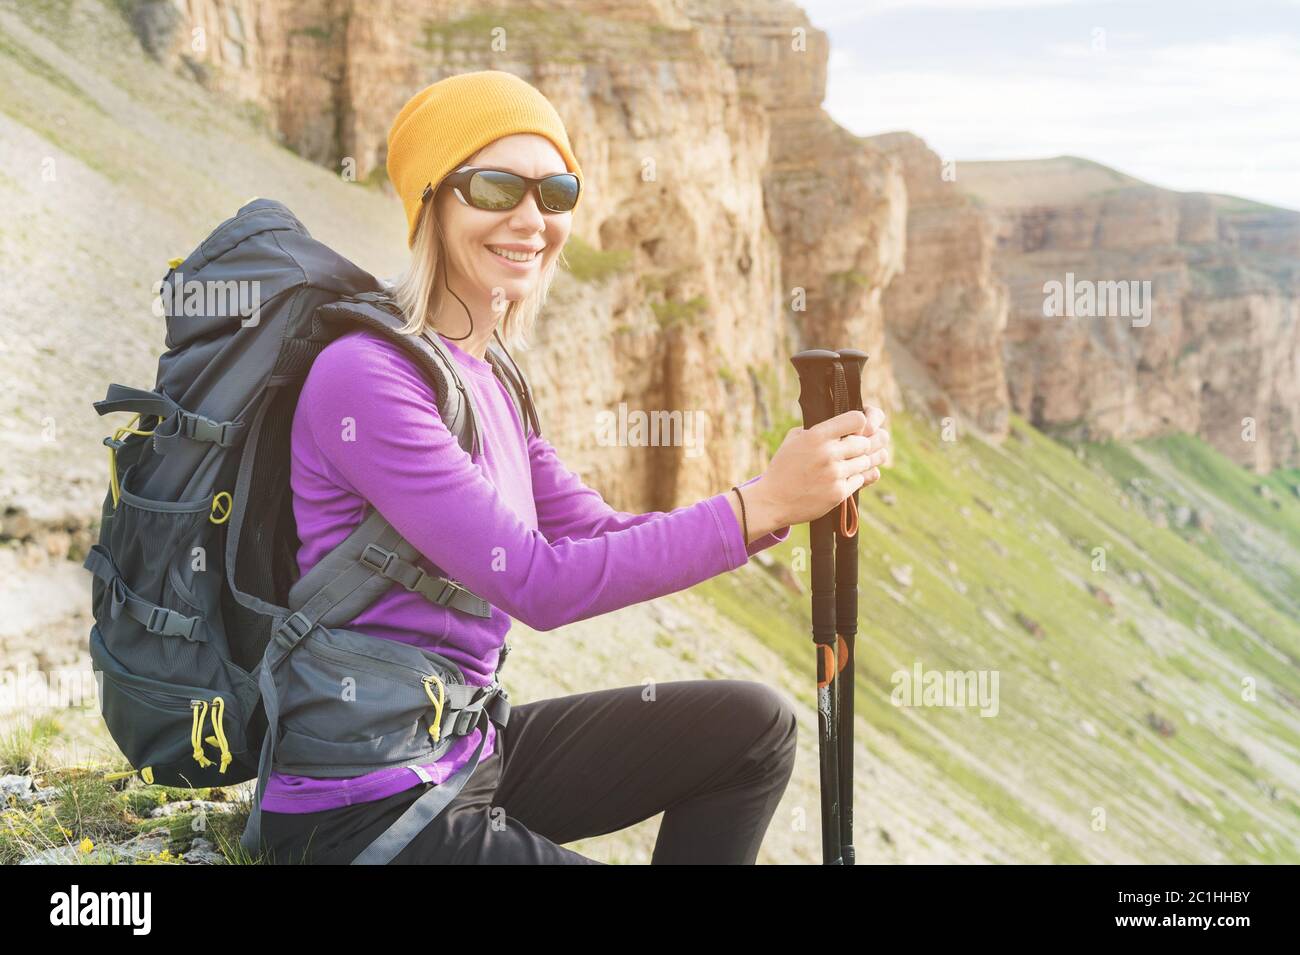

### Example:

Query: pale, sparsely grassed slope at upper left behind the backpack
xmin=0 ymin=0 xmax=407 ymax=520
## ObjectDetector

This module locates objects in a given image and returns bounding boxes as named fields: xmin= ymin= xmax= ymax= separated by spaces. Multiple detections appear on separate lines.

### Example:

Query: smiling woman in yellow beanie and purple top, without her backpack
xmin=263 ymin=70 xmax=888 ymax=864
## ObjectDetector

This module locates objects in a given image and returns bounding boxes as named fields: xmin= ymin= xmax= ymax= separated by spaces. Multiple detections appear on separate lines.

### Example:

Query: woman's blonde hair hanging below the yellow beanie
xmin=390 ymin=196 xmax=567 ymax=350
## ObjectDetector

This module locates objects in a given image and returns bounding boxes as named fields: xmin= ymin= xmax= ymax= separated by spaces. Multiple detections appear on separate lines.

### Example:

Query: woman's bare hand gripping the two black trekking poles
xmin=741 ymin=407 xmax=892 ymax=539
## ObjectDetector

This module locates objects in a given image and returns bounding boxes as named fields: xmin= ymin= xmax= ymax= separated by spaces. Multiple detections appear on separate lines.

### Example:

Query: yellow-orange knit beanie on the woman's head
xmin=389 ymin=70 xmax=582 ymax=248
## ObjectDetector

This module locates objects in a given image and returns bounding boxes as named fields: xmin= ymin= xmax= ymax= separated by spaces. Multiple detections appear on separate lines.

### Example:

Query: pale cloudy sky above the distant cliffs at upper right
xmin=796 ymin=0 xmax=1300 ymax=209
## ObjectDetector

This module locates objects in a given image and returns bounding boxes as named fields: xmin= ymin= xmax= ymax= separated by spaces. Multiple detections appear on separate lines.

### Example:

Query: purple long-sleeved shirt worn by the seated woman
xmin=263 ymin=330 xmax=790 ymax=812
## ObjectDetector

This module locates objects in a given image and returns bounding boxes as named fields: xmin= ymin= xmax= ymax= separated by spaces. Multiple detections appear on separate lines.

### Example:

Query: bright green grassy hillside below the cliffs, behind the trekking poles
xmin=701 ymin=416 xmax=1300 ymax=863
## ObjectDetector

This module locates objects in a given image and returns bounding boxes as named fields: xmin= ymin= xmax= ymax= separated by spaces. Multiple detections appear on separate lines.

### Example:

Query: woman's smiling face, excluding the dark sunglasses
xmin=438 ymin=133 xmax=573 ymax=301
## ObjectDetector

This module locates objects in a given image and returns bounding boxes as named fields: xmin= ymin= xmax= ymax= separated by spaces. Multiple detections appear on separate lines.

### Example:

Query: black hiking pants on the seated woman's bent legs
xmin=263 ymin=680 xmax=797 ymax=865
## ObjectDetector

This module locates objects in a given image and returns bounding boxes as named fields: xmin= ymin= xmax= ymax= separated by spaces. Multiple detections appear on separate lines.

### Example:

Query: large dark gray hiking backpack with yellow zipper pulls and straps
xmin=85 ymin=199 xmax=541 ymax=863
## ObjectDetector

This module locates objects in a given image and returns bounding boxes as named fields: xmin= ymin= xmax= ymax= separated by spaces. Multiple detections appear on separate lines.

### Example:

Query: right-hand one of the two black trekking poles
xmin=835 ymin=348 xmax=867 ymax=865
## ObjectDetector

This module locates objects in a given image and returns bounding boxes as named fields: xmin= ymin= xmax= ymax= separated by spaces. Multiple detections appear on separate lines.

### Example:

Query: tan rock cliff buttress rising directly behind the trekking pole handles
xmin=688 ymin=0 xmax=907 ymax=405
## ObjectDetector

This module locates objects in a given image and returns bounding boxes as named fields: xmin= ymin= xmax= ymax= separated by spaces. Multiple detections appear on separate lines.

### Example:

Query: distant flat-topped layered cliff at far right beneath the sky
xmin=958 ymin=157 xmax=1300 ymax=470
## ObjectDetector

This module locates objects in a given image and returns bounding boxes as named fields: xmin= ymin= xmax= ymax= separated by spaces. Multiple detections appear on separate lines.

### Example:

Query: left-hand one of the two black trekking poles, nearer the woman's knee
xmin=790 ymin=348 xmax=844 ymax=865
